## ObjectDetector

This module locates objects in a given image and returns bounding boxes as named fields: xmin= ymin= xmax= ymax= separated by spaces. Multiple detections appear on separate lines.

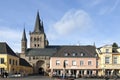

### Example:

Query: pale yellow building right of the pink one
xmin=97 ymin=45 xmax=120 ymax=76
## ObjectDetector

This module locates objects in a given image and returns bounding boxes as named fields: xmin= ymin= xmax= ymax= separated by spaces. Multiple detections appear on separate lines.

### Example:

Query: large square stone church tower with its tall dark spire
xmin=30 ymin=12 xmax=48 ymax=48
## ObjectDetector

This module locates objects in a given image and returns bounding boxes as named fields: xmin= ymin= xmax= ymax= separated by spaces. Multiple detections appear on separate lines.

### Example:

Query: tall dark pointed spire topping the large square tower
xmin=33 ymin=12 xmax=44 ymax=33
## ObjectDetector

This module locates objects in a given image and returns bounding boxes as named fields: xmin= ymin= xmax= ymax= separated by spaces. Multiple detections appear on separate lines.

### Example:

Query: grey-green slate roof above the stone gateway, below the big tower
xmin=26 ymin=48 xmax=57 ymax=56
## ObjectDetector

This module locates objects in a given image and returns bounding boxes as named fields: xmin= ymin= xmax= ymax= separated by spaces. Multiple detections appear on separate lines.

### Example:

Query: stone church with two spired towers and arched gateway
xmin=20 ymin=12 xmax=56 ymax=74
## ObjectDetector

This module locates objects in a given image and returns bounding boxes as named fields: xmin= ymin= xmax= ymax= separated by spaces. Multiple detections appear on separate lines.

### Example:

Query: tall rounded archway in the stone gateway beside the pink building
xmin=36 ymin=60 xmax=45 ymax=75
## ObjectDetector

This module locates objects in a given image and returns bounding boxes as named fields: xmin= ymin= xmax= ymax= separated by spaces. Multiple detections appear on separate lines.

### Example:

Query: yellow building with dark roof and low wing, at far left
xmin=0 ymin=42 xmax=33 ymax=75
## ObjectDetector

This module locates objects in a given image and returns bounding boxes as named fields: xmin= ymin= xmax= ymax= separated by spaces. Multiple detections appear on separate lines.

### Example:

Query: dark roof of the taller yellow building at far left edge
xmin=0 ymin=42 xmax=18 ymax=57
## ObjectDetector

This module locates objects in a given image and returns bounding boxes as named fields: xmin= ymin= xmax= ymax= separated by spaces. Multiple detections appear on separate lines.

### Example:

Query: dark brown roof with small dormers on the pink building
xmin=52 ymin=46 xmax=97 ymax=57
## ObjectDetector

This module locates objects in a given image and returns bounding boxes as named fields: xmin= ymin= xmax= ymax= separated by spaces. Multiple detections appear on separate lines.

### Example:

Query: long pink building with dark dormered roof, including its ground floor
xmin=50 ymin=46 xmax=98 ymax=77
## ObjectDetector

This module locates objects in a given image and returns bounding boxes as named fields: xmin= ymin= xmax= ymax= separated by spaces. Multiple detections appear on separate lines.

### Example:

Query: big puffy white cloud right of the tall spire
xmin=48 ymin=9 xmax=93 ymax=39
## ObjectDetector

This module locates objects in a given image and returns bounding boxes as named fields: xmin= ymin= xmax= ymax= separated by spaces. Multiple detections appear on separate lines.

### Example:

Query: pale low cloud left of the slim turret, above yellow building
xmin=0 ymin=26 xmax=22 ymax=52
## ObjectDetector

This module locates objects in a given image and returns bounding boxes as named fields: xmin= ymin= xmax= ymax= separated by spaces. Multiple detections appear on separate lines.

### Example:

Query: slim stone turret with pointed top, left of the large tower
xmin=21 ymin=28 xmax=27 ymax=53
